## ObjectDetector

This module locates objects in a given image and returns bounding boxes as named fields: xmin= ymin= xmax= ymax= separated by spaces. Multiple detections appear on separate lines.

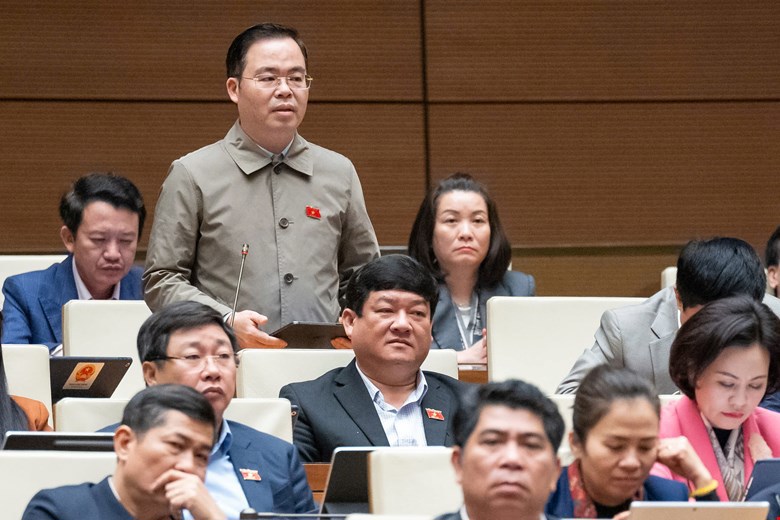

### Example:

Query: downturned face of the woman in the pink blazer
xmin=695 ymin=343 xmax=769 ymax=430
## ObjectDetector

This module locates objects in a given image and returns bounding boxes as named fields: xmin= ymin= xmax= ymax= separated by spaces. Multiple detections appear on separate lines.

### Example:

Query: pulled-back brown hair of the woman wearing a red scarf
xmin=572 ymin=365 xmax=661 ymax=444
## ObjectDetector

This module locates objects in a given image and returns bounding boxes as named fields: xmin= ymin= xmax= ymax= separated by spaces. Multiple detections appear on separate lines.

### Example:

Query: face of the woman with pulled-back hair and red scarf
xmin=571 ymin=397 xmax=658 ymax=506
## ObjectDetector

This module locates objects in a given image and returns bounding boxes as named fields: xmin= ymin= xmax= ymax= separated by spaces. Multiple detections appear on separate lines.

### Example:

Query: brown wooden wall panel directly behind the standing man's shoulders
xmin=0 ymin=101 xmax=425 ymax=253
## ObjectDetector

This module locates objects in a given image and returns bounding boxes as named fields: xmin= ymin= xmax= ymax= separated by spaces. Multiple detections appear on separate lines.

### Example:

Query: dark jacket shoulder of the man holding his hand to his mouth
xmin=22 ymin=477 xmax=133 ymax=520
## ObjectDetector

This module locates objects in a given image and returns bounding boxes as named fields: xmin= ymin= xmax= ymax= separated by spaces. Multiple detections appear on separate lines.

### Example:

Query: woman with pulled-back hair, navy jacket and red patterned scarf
xmin=545 ymin=365 xmax=717 ymax=518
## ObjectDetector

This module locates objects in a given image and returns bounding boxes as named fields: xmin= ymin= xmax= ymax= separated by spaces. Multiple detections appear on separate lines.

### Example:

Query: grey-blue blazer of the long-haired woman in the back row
xmin=431 ymin=271 xmax=536 ymax=350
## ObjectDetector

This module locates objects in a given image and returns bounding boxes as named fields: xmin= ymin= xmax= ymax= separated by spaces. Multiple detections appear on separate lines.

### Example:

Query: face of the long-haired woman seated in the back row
xmin=433 ymin=190 xmax=490 ymax=274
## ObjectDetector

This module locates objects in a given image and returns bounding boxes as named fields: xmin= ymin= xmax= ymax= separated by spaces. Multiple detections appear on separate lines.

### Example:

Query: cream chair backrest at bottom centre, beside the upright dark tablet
xmin=368 ymin=446 xmax=463 ymax=515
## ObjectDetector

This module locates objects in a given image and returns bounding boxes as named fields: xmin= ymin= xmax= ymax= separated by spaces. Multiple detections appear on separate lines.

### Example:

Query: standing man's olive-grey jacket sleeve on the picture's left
xmin=143 ymin=161 xmax=230 ymax=315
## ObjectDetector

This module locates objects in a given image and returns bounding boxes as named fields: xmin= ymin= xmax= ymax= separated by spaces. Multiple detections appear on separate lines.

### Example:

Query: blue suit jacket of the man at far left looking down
xmin=2 ymin=255 xmax=143 ymax=350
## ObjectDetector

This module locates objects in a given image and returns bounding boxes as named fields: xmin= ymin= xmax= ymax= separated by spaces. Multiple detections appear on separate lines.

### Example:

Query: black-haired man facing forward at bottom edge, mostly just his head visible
xmin=436 ymin=379 xmax=564 ymax=520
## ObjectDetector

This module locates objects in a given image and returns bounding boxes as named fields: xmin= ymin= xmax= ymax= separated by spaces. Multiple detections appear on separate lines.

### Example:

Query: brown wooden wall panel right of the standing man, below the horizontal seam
xmin=430 ymin=102 xmax=780 ymax=246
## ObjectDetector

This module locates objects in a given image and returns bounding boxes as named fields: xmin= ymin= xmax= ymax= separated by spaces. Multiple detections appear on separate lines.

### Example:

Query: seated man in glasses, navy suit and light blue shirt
xmin=125 ymin=301 xmax=315 ymax=519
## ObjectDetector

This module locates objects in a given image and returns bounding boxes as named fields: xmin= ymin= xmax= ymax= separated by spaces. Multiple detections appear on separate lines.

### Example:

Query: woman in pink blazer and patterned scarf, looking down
xmin=653 ymin=296 xmax=780 ymax=501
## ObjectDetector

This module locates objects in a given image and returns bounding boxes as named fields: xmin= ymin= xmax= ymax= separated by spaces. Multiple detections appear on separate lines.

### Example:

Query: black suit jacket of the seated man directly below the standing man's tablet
xmin=279 ymin=360 xmax=467 ymax=462
